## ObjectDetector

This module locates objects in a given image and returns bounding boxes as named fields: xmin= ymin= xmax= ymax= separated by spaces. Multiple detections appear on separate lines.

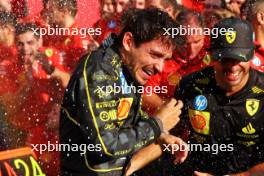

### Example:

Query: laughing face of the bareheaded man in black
xmin=121 ymin=32 xmax=173 ymax=85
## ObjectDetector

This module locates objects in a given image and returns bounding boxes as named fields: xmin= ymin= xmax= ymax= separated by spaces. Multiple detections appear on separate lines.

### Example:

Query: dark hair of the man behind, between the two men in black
xmin=176 ymin=9 xmax=206 ymax=28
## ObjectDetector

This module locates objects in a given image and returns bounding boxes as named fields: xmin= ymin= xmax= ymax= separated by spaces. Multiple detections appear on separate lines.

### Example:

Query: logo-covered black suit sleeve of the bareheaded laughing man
xmin=62 ymin=53 xmax=161 ymax=161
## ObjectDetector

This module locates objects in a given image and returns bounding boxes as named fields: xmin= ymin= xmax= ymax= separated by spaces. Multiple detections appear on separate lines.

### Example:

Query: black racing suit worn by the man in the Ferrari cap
xmin=170 ymin=67 xmax=264 ymax=176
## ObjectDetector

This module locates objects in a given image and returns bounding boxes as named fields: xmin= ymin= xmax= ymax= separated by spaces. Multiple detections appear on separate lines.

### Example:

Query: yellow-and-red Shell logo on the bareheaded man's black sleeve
xmin=117 ymin=98 xmax=133 ymax=120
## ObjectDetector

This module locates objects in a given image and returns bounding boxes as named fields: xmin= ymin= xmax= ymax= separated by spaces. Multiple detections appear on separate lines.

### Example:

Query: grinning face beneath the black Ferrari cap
xmin=214 ymin=58 xmax=250 ymax=95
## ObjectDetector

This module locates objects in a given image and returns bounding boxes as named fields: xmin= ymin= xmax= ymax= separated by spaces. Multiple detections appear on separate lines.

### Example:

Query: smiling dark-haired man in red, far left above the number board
xmin=8 ymin=23 xmax=70 ymax=175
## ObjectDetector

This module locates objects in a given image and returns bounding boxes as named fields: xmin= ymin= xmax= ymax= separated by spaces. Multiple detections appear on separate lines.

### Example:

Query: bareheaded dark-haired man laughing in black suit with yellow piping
xmin=60 ymin=9 xmax=186 ymax=175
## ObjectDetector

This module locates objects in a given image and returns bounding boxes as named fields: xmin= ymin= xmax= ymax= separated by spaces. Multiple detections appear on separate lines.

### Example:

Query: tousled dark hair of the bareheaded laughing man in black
xmin=118 ymin=8 xmax=177 ymax=47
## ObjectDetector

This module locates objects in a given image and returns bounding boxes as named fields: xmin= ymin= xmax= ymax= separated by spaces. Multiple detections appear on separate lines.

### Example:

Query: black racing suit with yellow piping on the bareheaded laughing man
xmin=60 ymin=35 xmax=161 ymax=176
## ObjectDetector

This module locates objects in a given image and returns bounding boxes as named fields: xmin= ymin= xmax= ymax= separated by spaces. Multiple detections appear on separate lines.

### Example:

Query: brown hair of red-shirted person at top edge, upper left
xmin=53 ymin=0 xmax=78 ymax=17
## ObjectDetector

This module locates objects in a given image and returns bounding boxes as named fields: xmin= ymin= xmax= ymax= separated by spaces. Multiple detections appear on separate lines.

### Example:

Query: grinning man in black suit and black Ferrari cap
xmin=173 ymin=18 xmax=264 ymax=175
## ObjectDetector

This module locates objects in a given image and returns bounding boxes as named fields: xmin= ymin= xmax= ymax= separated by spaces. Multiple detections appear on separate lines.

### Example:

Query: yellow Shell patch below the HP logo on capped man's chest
xmin=189 ymin=109 xmax=210 ymax=135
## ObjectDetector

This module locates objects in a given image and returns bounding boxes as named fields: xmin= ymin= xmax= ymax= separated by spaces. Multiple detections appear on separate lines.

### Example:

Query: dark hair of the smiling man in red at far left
xmin=16 ymin=23 xmax=40 ymax=39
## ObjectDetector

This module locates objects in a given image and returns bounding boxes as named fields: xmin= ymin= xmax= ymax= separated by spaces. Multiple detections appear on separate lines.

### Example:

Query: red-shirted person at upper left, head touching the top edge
xmin=43 ymin=0 xmax=88 ymax=73
